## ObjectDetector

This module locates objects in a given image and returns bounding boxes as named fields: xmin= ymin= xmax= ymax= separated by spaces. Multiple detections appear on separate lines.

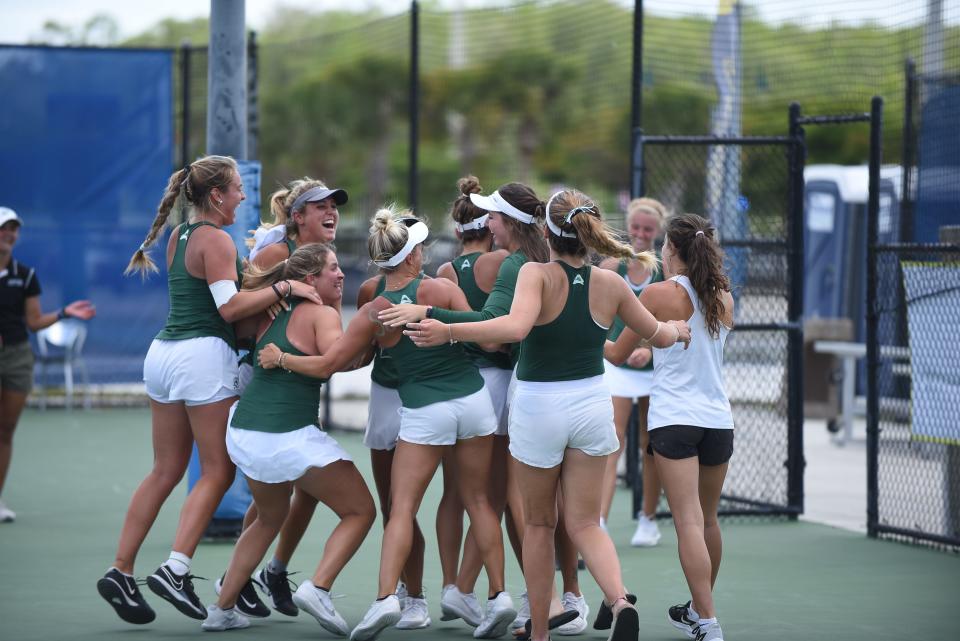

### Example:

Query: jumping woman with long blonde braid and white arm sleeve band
xmin=97 ymin=156 xmax=320 ymax=623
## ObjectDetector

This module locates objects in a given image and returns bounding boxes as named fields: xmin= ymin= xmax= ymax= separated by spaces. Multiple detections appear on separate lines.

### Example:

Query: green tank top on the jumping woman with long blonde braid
xmin=157 ymin=221 xmax=243 ymax=350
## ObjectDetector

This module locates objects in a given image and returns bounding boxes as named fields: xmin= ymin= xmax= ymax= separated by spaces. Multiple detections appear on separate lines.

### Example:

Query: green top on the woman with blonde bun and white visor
xmin=381 ymin=278 xmax=483 ymax=409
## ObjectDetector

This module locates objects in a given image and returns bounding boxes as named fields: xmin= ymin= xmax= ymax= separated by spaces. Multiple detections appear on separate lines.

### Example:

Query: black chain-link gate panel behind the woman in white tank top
xmin=628 ymin=124 xmax=804 ymax=517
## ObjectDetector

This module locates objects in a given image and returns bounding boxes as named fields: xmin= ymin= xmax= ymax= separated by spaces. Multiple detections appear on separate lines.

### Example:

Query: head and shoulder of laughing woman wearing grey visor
xmin=247 ymin=177 xmax=347 ymax=269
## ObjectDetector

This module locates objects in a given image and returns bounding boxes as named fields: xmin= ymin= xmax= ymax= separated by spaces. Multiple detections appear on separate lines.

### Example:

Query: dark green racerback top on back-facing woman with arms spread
xmin=517 ymin=260 xmax=610 ymax=381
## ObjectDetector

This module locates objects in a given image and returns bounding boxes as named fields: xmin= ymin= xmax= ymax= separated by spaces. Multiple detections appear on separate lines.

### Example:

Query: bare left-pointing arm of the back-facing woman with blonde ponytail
xmin=404 ymin=263 xmax=543 ymax=347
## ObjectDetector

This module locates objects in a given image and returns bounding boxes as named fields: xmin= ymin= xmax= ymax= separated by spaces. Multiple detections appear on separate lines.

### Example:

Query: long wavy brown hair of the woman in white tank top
xmin=666 ymin=214 xmax=730 ymax=337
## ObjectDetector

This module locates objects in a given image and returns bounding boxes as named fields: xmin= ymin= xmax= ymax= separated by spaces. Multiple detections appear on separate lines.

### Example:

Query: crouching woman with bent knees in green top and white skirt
xmin=203 ymin=243 xmax=376 ymax=636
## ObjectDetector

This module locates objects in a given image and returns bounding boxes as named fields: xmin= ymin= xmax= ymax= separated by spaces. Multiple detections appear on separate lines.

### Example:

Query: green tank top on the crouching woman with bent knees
xmin=230 ymin=298 xmax=327 ymax=433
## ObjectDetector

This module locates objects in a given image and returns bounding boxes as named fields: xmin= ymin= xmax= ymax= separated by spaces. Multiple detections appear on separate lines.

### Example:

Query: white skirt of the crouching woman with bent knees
xmin=227 ymin=401 xmax=353 ymax=483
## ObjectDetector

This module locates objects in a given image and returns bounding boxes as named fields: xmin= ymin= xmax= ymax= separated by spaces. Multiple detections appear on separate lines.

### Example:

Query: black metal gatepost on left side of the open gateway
xmin=787 ymin=102 xmax=807 ymax=519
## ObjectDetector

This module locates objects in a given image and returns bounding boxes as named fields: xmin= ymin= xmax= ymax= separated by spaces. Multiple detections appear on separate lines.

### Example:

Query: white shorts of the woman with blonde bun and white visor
xmin=400 ymin=389 xmax=497 ymax=445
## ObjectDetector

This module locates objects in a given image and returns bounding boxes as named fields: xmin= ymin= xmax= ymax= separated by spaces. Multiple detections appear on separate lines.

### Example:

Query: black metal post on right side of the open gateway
xmin=867 ymin=96 xmax=883 ymax=538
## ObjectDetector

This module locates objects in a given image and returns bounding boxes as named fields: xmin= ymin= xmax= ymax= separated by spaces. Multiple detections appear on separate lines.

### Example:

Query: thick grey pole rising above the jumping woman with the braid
xmin=207 ymin=0 xmax=247 ymax=160
